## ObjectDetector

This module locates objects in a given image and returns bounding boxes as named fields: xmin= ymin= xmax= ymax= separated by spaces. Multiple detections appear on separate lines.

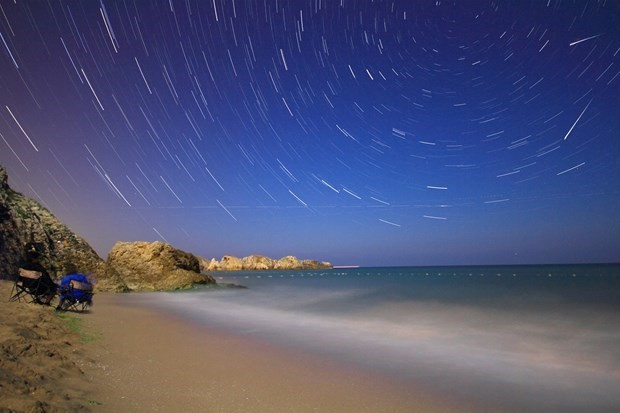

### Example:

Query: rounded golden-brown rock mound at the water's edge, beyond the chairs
xmin=107 ymin=241 xmax=215 ymax=291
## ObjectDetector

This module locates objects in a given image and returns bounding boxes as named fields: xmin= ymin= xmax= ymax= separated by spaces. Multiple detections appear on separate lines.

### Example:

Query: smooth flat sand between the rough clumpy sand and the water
xmin=82 ymin=293 xmax=474 ymax=412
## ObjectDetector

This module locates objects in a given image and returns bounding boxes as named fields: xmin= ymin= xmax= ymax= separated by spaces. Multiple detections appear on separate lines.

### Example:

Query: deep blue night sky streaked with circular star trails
xmin=0 ymin=0 xmax=620 ymax=265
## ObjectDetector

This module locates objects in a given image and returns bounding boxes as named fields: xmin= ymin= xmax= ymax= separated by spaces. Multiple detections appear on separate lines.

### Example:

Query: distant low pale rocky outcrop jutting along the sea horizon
xmin=199 ymin=255 xmax=332 ymax=271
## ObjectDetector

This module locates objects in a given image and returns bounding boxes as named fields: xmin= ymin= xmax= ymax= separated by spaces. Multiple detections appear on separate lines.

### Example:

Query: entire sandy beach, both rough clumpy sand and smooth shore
xmin=0 ymin=282 xmax=478 ymax=412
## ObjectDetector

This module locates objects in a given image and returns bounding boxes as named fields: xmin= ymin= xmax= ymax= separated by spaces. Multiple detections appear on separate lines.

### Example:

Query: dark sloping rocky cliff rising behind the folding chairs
xmin=0 ymin=166 xmax=126 ymax=291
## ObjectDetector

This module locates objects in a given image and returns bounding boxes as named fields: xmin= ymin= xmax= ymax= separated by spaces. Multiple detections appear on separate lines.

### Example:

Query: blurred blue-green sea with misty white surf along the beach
xmin=148 ymin=265 xmax=620 ymax=412
